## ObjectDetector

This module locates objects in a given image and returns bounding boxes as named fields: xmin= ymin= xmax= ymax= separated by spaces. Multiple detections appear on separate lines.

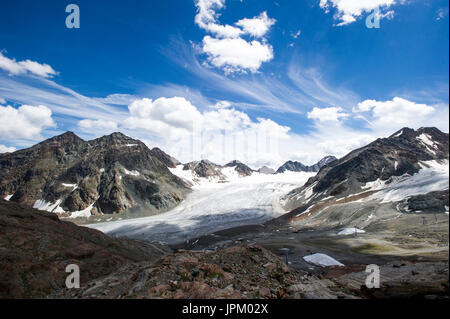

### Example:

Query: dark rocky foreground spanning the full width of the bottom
xmin=0 ymin=201 xmax=448 ymax=299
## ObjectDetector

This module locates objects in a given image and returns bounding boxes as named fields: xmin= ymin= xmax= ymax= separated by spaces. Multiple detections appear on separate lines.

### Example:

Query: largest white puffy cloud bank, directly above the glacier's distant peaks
xmin=123 ymin=97 xmax=290 ymax=165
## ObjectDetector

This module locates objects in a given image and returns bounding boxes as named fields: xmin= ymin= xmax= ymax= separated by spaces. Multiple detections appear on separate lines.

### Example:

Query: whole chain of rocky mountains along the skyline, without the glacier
xmin=0 ymin=128 xmax=448 ymax=224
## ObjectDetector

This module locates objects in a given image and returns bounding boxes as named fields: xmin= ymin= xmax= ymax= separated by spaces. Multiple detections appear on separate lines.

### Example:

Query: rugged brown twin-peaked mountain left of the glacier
xmin=0 ymin=132 xmax=189 ymax=218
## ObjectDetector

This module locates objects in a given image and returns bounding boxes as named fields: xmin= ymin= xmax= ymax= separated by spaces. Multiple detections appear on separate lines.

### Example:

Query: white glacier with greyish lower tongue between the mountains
xmin=87 ymin=169 xmax=315 ymax=244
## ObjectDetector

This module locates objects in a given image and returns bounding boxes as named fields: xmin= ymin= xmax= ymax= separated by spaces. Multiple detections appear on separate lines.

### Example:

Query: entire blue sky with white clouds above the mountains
xmin=0 ymin=0 xmax=449 ymax=167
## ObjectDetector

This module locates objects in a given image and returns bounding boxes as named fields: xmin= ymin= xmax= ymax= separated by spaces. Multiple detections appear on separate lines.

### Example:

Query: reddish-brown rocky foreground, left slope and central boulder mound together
xmin=0 ymin=201 xmax=346 ymax=298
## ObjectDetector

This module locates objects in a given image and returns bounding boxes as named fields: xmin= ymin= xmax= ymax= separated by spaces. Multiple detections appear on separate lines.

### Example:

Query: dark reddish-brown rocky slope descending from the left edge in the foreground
xmin=0 ymin=200 xmax=170 ymax=298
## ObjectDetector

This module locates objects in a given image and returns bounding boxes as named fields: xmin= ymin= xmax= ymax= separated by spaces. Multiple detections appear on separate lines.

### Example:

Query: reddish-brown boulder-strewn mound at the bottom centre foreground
xmin=56 ymin=246 xmax=323 ymax=299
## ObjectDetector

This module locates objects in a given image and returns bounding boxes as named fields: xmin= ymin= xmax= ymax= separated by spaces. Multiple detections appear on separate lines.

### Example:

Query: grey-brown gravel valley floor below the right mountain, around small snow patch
xmin=175 ymin=203 xmax=449 ymax=298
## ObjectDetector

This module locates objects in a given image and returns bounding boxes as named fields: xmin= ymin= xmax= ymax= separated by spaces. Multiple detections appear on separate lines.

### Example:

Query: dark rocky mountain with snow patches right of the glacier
xmin=285 ymin=128 xmax=449 ymax=209
